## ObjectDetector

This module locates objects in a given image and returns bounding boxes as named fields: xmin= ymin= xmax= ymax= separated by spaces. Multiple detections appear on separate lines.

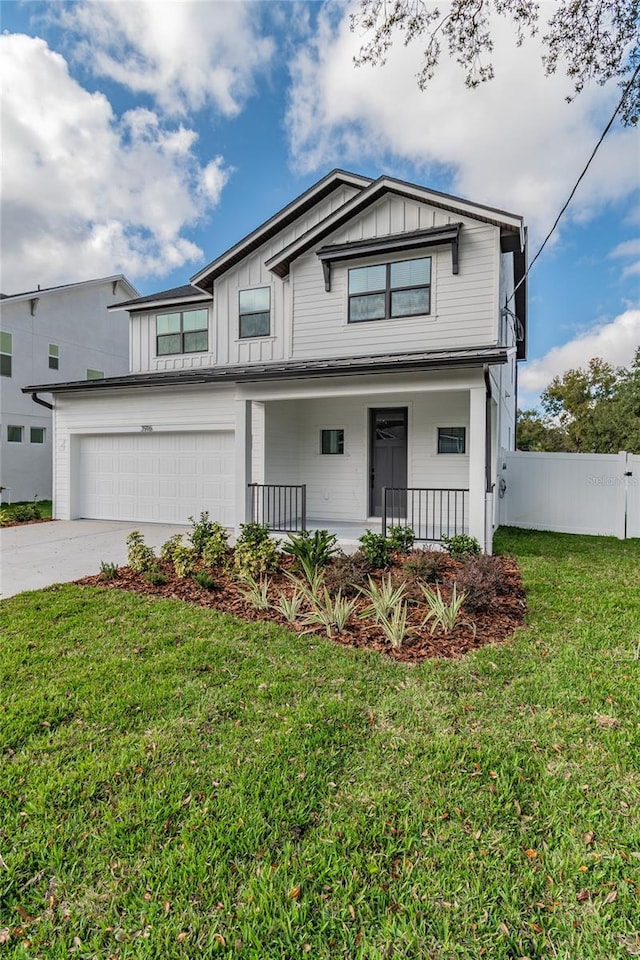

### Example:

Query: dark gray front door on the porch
xmin=369 ymin=407 xmax=407 ymax=517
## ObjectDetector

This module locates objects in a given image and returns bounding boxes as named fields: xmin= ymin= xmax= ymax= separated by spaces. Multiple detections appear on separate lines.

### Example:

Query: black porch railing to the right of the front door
xmin=382 ymin=487 xmax=469 ymax=541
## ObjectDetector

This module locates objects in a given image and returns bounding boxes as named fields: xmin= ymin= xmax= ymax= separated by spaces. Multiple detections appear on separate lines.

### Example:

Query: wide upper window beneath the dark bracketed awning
xmin=349 ymin=257 xmax=431 ymax=323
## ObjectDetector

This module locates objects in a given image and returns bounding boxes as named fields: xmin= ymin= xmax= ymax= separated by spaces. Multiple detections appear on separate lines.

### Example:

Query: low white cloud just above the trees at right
xmin=518 ymin=310 xmax=640 ymax=407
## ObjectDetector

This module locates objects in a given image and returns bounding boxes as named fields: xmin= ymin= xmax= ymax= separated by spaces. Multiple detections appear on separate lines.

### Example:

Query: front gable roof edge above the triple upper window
xmin=266 ymin=176 xmax=524 ymax=277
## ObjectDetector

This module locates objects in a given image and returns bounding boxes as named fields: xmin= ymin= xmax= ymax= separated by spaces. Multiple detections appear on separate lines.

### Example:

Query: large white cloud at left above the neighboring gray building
xmin=0 ymin=34 xmax=228 ymax=293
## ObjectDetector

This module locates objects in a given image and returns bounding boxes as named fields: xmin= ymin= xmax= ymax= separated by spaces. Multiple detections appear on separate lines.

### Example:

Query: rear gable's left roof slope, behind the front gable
xmin=191 ymin=169 xmax=371 ymax=292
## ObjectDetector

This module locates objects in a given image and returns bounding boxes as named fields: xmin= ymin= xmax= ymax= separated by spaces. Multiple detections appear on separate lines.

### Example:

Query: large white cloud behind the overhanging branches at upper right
xmin=287 ymin=7 xmax=638 ymax=238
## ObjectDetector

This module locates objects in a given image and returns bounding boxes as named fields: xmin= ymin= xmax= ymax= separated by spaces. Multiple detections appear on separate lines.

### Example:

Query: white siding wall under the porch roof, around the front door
xmin=265 ymin=391 xmax=469 ymax=520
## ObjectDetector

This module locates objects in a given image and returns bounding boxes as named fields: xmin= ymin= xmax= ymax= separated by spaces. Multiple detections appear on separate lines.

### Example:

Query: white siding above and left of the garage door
xmin=53 ymin=386 xmax=235 ymax=520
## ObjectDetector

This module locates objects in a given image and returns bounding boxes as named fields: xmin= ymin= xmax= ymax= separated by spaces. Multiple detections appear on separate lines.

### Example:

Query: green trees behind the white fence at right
xmin=516 ymin=348 xmax=640 ymax=454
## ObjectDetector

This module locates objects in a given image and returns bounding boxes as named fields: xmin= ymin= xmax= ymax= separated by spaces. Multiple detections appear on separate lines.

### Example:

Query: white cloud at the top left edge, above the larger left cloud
xmin=53 ymin=0 xmax=275 ymax=116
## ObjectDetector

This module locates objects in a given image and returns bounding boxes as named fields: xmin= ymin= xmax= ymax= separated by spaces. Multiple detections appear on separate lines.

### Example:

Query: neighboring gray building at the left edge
xmin=0 ymin=274 xmax=137 ymax=502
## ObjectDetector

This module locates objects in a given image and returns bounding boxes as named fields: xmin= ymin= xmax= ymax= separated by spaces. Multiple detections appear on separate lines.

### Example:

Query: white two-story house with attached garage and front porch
xmin=23 ymin=170 xmax=526 ymax=547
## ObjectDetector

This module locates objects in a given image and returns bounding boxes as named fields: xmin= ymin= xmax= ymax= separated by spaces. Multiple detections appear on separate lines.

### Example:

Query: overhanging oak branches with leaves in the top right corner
xmin=351 ymin=0 xmax=640 ymax=126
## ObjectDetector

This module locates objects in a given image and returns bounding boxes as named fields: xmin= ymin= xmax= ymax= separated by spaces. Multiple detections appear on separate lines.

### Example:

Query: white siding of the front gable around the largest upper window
xmin=291 ymin=197 xmax=500 ymax=359
